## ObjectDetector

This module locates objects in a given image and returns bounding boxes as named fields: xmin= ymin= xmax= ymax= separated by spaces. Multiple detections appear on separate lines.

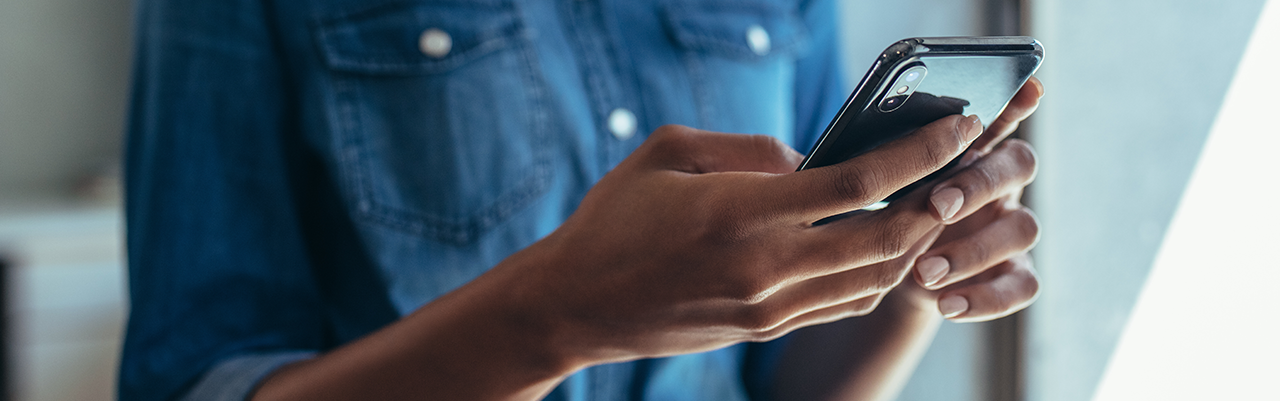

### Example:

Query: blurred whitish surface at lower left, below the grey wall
xmin=0 ymin=205 xmax=127 ymax=401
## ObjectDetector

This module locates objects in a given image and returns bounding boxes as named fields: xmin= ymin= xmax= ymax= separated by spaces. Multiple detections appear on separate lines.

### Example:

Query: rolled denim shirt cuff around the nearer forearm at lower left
xmin=182 ymin=351 xmax=316 ymax=401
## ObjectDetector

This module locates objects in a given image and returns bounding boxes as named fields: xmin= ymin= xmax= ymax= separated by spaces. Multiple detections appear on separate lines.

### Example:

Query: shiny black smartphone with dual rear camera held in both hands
xmin=799 ymin=36 xmax=1044 ymax=206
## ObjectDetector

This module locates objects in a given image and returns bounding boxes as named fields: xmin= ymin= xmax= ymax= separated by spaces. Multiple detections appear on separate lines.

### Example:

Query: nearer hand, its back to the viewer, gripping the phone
xmin=490 ymin=115 xmax=986 ymax=368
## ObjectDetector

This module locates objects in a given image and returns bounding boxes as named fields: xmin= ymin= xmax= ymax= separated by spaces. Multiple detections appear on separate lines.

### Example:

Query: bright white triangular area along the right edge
xmin=1094 ymin=0 xmax=1280 ymax=401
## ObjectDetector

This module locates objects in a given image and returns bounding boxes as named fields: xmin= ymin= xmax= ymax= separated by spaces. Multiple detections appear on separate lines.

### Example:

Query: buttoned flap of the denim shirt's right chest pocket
xmin=663 ymin=1 xmax=808 ymax=59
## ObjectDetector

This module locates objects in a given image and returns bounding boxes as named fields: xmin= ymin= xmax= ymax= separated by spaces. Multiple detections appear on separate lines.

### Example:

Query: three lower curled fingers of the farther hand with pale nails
xmin=899 ymin=140 xmax=1039 ymax=322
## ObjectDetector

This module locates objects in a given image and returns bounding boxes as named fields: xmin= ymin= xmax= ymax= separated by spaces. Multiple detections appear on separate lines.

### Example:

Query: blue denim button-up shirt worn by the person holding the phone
xmin=119 ymin=0 xmax=846 ymax=400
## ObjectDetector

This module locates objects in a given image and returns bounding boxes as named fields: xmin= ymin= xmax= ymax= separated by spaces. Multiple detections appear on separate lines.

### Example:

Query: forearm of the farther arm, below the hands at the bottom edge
xmin=773 ymin=293 xmax=942 ymax=400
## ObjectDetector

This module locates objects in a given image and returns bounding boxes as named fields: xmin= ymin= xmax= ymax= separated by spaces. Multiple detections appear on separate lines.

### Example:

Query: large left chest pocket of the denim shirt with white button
xmin=315 ymin=0 xmax=550 ymax=245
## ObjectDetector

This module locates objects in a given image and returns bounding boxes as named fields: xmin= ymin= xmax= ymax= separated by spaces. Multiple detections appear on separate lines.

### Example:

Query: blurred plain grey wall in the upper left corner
xmin=0 ymin=0 xmax=132 ymax=197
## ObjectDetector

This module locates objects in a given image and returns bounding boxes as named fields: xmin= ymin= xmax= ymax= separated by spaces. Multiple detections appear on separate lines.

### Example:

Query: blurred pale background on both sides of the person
xmin=0 ymin=0 xmax=1280 ymax=401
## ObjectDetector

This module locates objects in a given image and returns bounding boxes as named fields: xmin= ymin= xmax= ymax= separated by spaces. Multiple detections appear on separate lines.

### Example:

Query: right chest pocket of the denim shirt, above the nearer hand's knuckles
xmin=662 ymin=0 xmax=809 ymax=141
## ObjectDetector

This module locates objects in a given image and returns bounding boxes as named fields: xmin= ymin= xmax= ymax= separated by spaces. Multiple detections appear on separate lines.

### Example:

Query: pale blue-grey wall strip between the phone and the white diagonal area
xmin=1028 ymin=0 xmax=1263 ymax=400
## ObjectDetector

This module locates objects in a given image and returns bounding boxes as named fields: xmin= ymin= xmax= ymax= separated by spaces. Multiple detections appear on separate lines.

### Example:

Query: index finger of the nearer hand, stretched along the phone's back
xmin=756 ymin=115 xmax=982 ymax=223
